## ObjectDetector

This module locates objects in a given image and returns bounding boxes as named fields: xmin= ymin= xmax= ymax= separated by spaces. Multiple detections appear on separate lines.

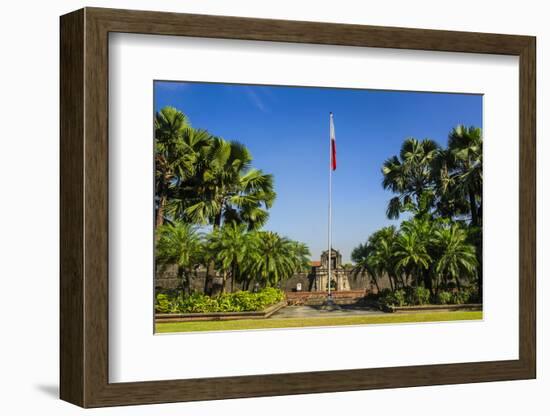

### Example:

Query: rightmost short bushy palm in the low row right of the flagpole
xmin=433 ymin=223 xmax=477 ymax=288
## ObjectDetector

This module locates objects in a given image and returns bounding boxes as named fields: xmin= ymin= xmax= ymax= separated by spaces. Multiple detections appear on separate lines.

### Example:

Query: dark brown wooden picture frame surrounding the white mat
xmin=60 ymin=8 xmax=536 ymax=407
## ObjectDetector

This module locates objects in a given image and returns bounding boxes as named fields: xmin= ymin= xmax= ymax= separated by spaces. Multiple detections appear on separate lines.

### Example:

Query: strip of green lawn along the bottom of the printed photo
xmin=156 ymin=311 xmax=483 ymax=333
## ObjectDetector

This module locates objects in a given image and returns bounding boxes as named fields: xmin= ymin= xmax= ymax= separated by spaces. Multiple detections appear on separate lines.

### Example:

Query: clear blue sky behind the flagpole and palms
xmin=154 ymin=81 xmax=482 ymax=262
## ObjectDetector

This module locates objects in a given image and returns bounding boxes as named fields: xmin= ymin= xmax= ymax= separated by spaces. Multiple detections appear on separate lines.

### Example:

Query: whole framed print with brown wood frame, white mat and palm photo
xmin=60 ymin=8 xmax=536 ymax=407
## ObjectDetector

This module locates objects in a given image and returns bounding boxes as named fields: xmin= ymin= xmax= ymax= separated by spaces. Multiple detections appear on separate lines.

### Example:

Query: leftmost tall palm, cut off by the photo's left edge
xmin=155 ymin=107 xmax=189 ymax=229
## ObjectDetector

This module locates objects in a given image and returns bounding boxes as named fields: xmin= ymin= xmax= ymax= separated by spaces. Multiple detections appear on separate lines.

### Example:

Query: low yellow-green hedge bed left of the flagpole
xmin=155 ymin=288 xmax=285 ymax=313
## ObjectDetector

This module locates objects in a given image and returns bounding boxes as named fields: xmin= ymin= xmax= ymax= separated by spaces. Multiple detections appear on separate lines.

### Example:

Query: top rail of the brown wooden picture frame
xmin=86 ymin=8 xmax=530 ymax=55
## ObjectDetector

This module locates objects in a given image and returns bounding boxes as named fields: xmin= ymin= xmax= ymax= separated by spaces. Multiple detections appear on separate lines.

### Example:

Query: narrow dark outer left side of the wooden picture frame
xmin=59 ymin=10 xmax=85 ymax=406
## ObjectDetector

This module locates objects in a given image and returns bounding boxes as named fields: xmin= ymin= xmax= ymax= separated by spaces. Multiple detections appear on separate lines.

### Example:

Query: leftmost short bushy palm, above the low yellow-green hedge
xmin=155 ymin=221 xmax=202 ymax=293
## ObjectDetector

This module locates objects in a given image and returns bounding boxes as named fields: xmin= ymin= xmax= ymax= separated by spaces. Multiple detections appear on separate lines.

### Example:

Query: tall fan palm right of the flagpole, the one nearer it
xmin=382 ymin=138 xmax=439 ymax=219
